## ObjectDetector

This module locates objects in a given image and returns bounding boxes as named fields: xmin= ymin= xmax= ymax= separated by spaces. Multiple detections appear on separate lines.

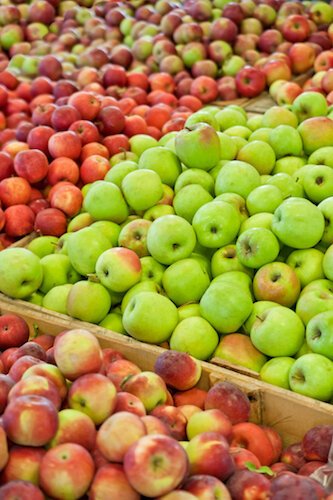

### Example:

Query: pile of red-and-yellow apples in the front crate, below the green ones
xmin=0 ymin=314 xmax=333 ymax=500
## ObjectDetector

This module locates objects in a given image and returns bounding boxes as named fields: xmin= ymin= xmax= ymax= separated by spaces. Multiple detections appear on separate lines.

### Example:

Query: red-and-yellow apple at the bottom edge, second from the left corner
xmin=39 ymin=443 xmax=95 ymax=498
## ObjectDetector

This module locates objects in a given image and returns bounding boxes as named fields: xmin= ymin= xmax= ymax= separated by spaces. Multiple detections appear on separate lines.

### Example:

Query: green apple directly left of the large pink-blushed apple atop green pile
xmin=138 ymin=146 xmax=181 ymax=187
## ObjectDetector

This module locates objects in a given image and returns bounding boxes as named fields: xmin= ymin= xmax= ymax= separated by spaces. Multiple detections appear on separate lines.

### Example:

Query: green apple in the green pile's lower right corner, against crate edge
xmin=289 ymin=353 xmax=333 ymax=401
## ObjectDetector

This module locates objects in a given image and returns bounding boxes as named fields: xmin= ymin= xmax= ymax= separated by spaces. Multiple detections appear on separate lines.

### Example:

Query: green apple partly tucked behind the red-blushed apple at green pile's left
xmin=67 ymin=226 xmax=110 ymax=276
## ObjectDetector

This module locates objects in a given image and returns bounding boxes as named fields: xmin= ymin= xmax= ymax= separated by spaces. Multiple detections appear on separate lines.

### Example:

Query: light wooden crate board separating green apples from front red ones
xmin=0 ymin=294 xmax=333 ymax=444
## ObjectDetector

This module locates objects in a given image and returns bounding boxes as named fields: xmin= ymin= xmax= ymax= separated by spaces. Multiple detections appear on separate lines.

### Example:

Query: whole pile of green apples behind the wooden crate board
xmin=0 ymin=92 xmax=333 ymax=402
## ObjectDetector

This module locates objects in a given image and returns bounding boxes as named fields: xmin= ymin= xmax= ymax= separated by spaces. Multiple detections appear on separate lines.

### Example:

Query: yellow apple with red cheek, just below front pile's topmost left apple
xmin=67 ymin=373 xmax=117 ymax=425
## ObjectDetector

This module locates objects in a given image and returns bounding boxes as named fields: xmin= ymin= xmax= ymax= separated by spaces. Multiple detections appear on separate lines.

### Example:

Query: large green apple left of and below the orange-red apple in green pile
xmin=200 ymin=284 xmax=253 ymax=333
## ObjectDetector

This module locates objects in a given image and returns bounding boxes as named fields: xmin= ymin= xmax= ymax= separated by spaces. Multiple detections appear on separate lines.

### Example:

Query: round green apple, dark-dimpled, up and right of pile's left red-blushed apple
xmin=147 ymin=215 xmax=196 ymax=265
